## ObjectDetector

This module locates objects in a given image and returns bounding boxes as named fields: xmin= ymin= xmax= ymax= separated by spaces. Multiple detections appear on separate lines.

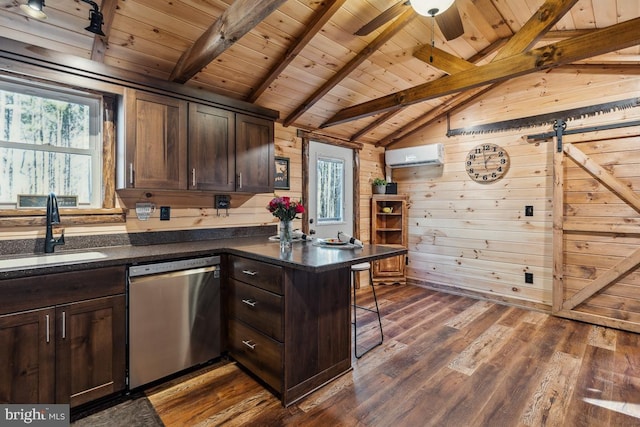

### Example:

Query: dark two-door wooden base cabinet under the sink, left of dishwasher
xmin=0 ymin=267 xmax=126 ymax=407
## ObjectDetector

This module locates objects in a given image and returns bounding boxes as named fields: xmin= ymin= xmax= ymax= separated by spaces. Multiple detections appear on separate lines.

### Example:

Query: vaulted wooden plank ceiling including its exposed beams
xmin=0 ymin=0 xmax=640 ymax=146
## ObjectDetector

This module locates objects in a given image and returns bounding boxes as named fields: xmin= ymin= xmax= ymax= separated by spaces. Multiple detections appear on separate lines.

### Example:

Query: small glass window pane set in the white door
xmin=317 ymin=158 xmax=344 ymax=223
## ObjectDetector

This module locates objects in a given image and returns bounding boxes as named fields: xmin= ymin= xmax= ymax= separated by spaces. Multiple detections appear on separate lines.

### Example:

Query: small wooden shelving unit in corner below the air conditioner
xmin=371 ymin=194 xmax=408 ymax=284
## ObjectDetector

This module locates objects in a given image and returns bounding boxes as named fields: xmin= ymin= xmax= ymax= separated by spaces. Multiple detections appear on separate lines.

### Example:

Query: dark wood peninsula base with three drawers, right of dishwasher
xmin=227 ymin=256 xmax=351 ymax=406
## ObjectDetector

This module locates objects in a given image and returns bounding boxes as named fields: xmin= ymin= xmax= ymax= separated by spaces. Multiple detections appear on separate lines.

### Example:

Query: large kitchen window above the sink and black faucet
xmin=0 ymin=80 xmax=102 ymax=208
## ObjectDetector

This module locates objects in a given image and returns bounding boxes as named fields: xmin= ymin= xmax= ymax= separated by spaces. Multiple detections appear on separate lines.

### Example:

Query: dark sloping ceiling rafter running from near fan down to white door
xmin=283 ymin=7 xmax=417 ymax=126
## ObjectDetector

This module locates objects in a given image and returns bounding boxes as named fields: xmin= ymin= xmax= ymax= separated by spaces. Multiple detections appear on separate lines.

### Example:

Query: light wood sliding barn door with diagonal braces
xmin=553 ymin=127 xmax=640 ymax=332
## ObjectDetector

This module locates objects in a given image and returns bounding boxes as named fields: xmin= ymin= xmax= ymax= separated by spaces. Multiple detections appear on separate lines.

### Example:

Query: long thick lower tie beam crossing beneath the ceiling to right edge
xmin=321 ymin=18 xmax=640 ymax=128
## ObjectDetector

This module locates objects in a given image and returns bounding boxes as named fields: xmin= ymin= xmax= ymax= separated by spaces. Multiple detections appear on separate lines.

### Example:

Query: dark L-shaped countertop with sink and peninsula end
xmin=0 ymin=236 xmax=407 ymax=279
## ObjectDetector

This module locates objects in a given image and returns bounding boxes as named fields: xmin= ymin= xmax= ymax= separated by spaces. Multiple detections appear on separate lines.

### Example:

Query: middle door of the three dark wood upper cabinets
xmin=189 ymin=104 xmax=236 ymax=191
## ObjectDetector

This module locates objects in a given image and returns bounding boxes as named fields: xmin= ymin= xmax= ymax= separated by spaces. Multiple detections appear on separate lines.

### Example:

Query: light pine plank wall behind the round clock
xmin=391 ymin=67 xmax=640 ymax=310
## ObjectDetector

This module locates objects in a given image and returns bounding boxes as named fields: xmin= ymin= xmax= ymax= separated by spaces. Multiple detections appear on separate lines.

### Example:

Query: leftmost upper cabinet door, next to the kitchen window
xmin=121 ymin=90 xmax=187 ymax=190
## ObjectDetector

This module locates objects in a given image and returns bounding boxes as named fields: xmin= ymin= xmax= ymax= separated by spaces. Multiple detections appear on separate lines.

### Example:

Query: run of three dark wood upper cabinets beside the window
xmin=117 ymin=89 xmax=274 ymax=193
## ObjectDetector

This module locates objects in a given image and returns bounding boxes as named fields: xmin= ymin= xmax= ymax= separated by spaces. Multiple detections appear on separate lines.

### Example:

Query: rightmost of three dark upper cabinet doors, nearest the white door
xmin=236 ymin=114 xmax=275 ymax=193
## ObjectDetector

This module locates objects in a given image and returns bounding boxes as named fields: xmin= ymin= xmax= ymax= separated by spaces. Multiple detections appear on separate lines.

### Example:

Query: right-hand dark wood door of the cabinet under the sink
xmin=56 ymin=295 xmax=126 ymax=407
